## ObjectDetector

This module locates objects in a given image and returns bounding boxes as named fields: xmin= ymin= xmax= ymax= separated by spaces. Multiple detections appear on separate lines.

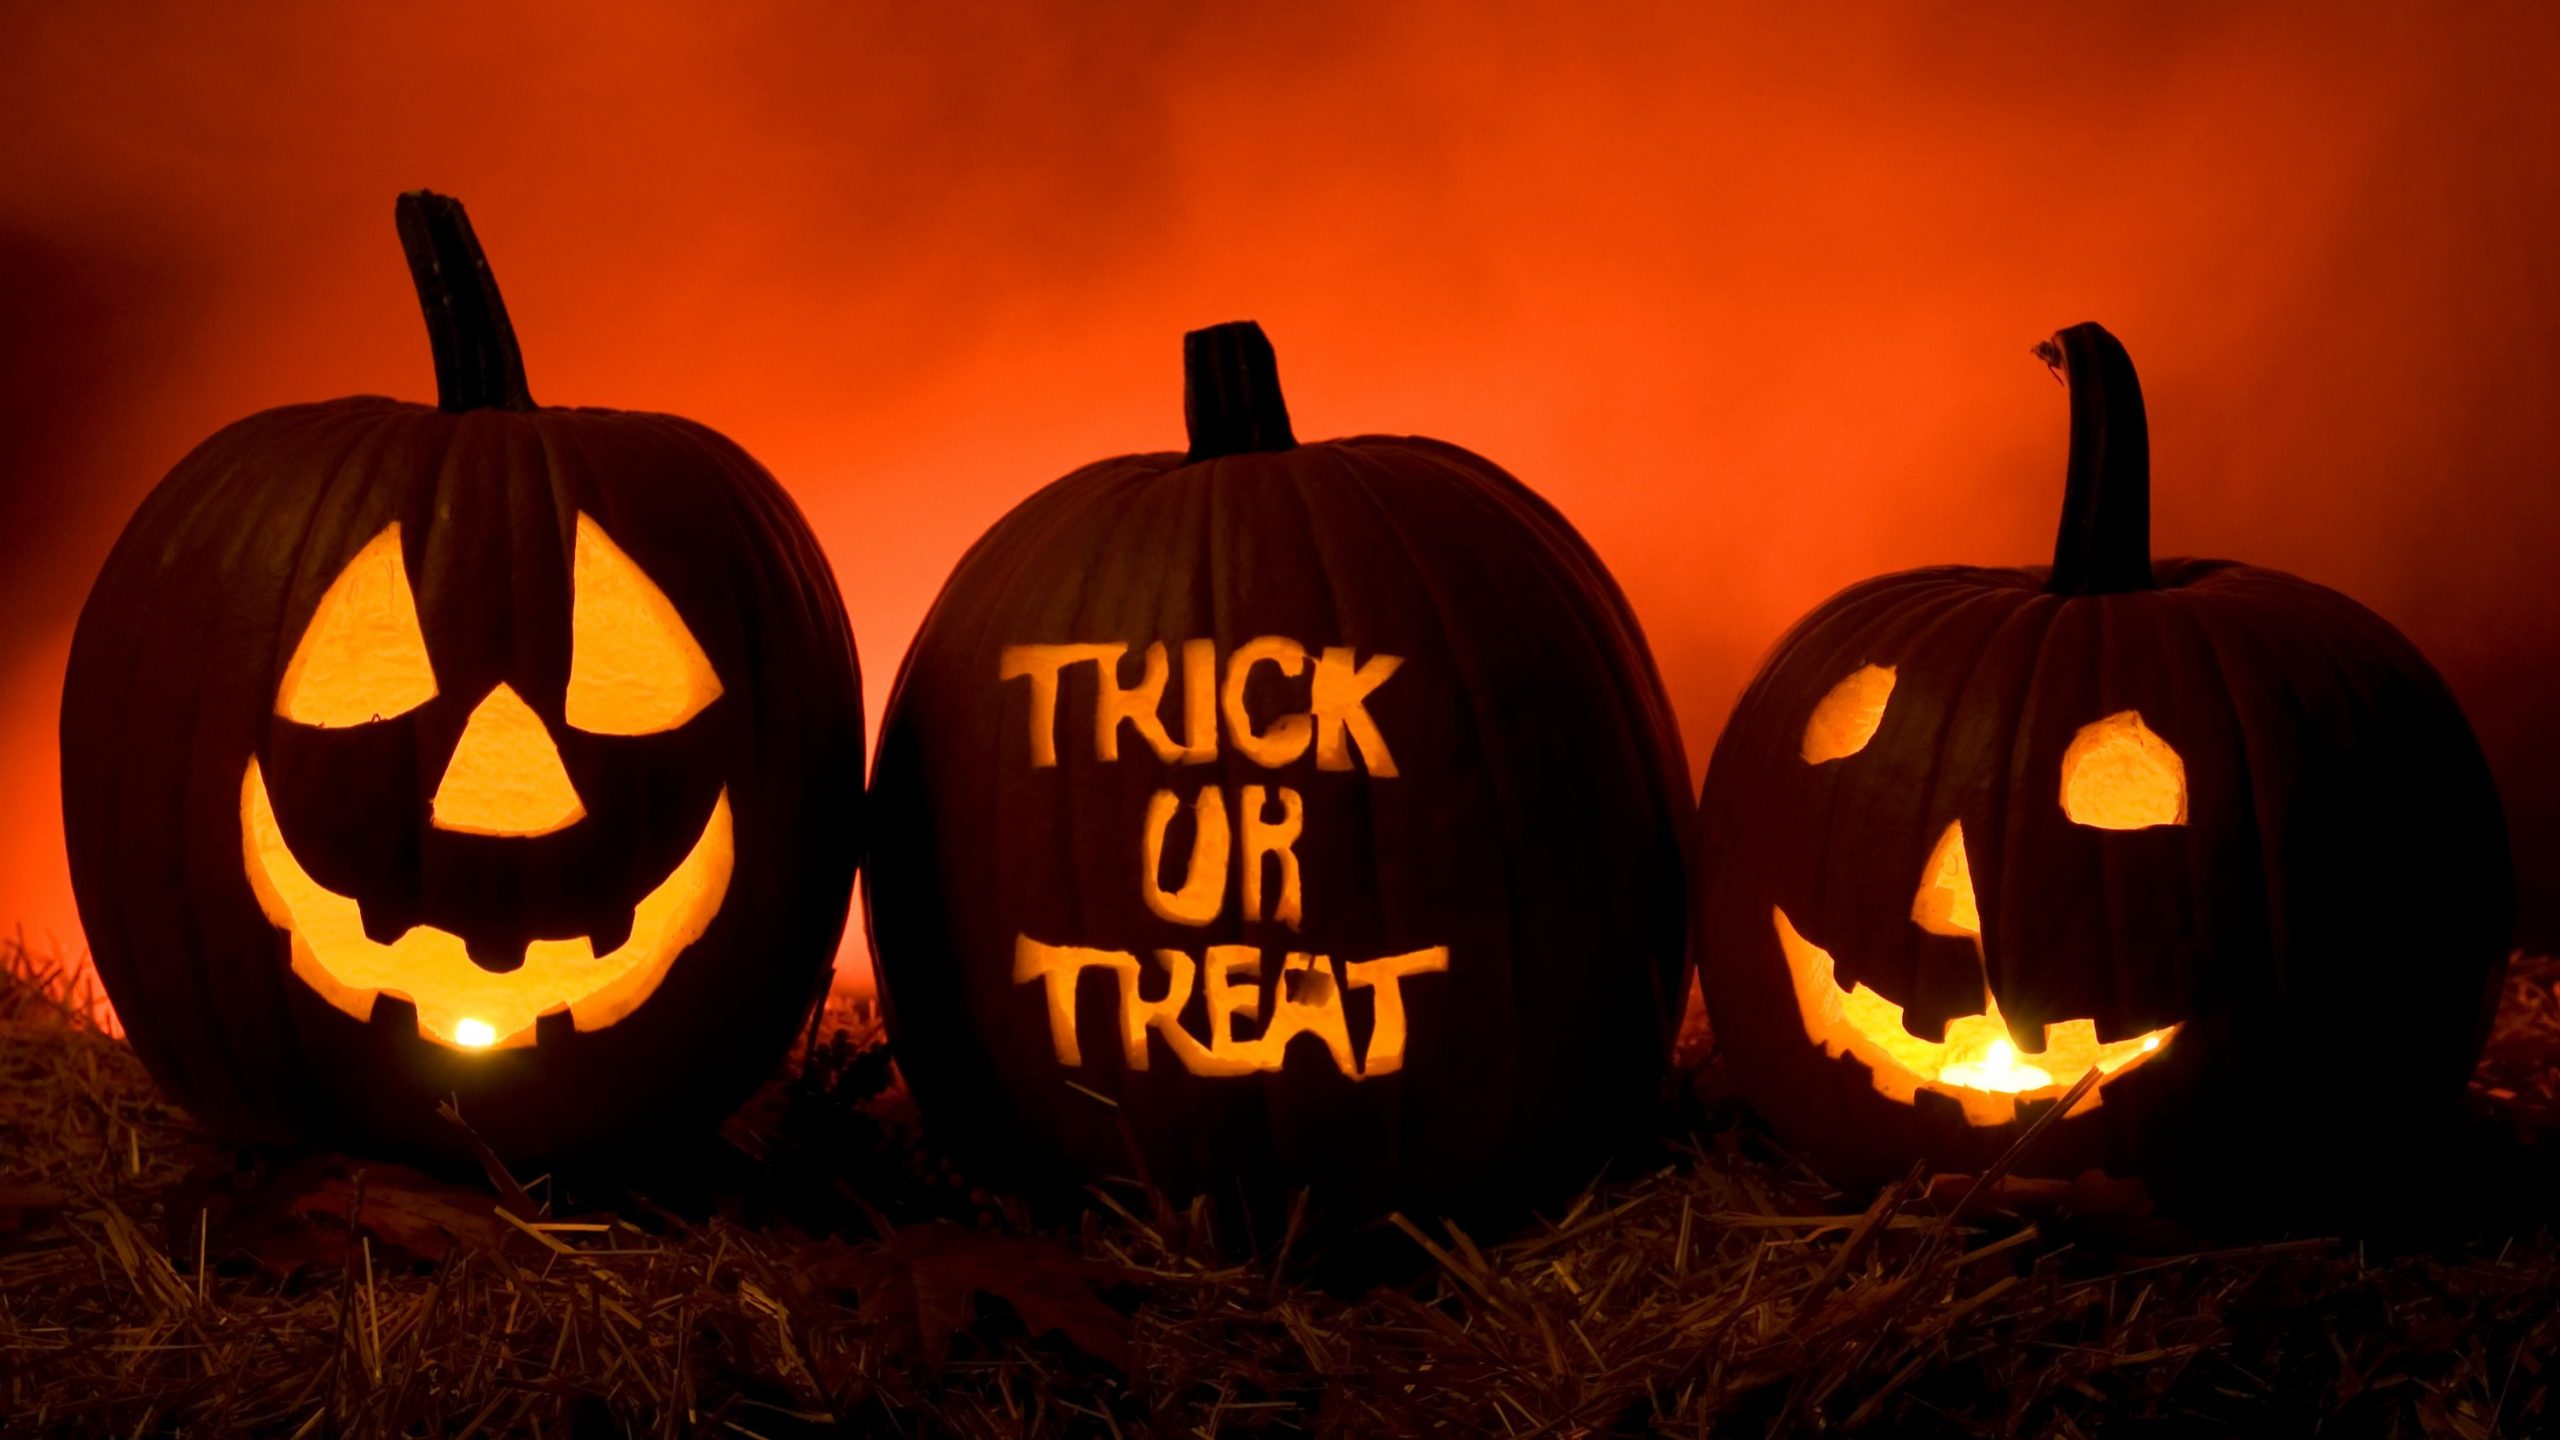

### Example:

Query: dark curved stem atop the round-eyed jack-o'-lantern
xmin=2035 ymin=320 xmax=2153 ymax=594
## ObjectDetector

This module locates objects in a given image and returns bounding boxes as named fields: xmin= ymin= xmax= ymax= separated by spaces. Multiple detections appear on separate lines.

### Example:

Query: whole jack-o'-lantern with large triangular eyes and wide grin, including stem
xmin=61 ymin=192 xmax=863 ymax=1158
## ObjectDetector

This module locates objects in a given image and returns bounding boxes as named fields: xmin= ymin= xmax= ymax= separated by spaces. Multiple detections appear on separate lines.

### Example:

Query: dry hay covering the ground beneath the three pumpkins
xmin=0 ymin=932 xmax=2560 ymax=1437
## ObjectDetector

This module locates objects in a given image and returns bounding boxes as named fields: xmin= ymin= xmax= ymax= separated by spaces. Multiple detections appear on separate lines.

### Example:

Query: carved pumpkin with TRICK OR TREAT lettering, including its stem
xmin=865 ymin=323 xmax=1690 ymax=1217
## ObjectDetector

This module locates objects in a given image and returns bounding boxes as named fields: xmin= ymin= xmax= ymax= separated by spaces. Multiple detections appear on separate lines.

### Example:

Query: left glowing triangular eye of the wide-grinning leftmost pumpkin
xmin=276 ymin=523 xmax=435 ymax=730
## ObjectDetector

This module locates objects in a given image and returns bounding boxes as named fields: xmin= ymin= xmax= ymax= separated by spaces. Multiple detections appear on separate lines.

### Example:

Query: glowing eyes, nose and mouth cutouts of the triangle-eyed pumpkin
xmin=241 ymin=515 xmax=735 ymax=1051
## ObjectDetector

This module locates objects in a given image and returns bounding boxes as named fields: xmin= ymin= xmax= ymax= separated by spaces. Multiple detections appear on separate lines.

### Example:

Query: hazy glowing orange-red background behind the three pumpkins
xmin=0 ymin=0 xmax=2560 ymax=1004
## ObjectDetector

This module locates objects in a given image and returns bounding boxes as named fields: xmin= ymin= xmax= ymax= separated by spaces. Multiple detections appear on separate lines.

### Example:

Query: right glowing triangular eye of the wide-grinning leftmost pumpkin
xmin=566 ymin=515 xmax=719 ymax=735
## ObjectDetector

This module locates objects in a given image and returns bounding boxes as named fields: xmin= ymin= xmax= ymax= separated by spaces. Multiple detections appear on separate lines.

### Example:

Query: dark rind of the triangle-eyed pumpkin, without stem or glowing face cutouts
xmin=61 ymin=193 xmax=863 ymax=1163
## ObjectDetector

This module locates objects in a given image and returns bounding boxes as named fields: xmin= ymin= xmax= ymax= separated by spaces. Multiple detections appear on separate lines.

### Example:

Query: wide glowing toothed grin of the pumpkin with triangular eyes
xmin=241 ymin=756 xmax=732 ymax=1051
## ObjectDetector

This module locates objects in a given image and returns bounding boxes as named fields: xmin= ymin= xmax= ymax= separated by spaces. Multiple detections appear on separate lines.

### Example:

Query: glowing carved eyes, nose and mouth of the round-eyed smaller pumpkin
xmin=1769 ymin=666 xmax=2186 ymax=1125
